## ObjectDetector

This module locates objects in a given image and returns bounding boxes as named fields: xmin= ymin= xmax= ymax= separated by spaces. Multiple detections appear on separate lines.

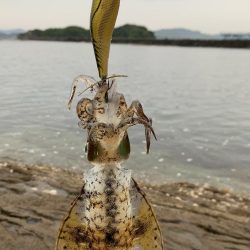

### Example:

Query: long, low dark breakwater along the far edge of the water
xmin=18 ymin=39 xmax=250 ymax=49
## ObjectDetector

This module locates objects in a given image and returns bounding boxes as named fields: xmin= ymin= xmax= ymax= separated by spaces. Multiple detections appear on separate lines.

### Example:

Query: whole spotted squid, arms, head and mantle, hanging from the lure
xmin=56 ymin=80 xmax=163 ymax=250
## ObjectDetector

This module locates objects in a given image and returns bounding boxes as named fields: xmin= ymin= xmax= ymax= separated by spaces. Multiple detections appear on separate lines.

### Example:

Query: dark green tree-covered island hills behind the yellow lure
xmin=18 ymin=24 xmax=155 ymax=41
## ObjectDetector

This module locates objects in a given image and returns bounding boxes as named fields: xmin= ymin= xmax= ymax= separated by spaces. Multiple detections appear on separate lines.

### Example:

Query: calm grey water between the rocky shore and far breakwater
xmin=0 ymin=41 xmax=250 ymax=192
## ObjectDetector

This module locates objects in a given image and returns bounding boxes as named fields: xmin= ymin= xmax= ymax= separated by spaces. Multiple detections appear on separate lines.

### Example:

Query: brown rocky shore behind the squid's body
xmin=0 ymin=161 xmax=250 ymax=250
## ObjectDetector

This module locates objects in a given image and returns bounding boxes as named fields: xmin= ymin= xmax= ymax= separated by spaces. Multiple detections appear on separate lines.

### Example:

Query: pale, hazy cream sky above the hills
xmin=0 ymin=0 xmax=250 ymax=34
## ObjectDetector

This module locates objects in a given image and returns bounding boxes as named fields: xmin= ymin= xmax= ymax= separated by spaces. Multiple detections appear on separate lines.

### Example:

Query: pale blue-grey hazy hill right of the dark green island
xmin=154 ymin=28 xmax=223 ymax=40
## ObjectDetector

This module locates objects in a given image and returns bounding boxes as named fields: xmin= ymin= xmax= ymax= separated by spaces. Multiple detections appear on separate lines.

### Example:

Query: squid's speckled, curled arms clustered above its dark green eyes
xmin=73 ymin=81 xmax=156 ymax=159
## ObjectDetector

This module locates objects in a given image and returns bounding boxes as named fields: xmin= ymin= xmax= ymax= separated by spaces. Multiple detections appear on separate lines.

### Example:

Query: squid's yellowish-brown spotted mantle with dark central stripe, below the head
xmin=57 ymin=165 xmax=163 ymax=250
